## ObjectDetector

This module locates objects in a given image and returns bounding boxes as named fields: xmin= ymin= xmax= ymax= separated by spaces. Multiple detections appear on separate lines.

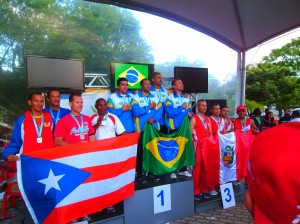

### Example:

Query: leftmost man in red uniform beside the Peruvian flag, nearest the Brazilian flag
xmin=190 ymin=100 xmax=220 ymax=200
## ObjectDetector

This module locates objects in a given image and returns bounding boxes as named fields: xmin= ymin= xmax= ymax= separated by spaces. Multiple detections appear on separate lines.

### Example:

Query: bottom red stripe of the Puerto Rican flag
xmin=43 ymin=182 xmax=134 ymax=224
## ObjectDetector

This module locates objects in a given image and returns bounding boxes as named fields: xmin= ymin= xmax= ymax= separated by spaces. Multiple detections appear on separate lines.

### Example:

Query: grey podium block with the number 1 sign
xmin=123 ymin=179 xmax=194 ymax=224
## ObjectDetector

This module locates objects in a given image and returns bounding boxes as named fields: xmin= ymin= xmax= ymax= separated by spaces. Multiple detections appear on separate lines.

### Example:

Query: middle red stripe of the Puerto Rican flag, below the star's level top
xmin=82 ymin=157 xmax=136 ymax=184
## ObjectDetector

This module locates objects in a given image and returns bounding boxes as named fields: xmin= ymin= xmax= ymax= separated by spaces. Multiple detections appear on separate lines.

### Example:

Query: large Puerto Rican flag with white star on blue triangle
xmin=17 ymin=133 xmax=138 ymax=224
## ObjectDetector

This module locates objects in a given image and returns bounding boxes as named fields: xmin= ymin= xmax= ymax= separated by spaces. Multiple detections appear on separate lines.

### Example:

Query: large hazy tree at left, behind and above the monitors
xmin=0 ymin=0 xmax=153 ymax=121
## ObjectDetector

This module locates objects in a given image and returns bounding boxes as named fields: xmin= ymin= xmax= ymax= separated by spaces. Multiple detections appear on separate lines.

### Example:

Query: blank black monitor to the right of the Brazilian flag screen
xmin=174 ymin=66 xmax=208 ymax=93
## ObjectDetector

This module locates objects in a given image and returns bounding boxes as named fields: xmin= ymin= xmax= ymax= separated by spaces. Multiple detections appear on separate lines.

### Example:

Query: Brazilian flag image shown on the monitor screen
xmin=115 ymin=64 xmax=148 ymax=89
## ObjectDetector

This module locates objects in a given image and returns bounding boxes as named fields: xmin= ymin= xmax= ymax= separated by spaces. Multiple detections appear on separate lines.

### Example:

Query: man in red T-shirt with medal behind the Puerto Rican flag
xmin=54 ymin=93 xmax=95 ymax=146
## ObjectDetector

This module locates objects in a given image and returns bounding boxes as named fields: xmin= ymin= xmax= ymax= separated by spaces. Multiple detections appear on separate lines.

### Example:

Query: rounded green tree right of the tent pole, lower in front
xmin=246 ymin=62 xmax=300 ymax=109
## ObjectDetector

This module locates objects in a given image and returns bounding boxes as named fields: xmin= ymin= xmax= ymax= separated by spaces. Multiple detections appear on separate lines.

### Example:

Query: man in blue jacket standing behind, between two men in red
xmin=44 ymin=89 xmax=71 ymax=132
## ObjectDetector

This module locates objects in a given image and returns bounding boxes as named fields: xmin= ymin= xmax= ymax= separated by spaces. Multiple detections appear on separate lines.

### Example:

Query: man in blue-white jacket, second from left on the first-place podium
xmin=131 ymin=79 xmax=163 ymax=183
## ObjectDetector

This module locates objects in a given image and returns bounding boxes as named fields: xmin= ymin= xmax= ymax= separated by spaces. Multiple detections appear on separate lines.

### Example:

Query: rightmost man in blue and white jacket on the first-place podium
xmin=165 ymin=79 xmax=193 ymax=179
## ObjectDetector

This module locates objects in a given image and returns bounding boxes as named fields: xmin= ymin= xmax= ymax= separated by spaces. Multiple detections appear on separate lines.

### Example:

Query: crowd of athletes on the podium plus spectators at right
xmin=2 ymin=72 xmax=298 ymax=222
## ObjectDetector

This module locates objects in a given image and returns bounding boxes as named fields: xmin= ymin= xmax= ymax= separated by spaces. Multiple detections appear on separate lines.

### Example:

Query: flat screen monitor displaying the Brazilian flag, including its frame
xmin=110 ymin=62 xmax=154 ymax=90
